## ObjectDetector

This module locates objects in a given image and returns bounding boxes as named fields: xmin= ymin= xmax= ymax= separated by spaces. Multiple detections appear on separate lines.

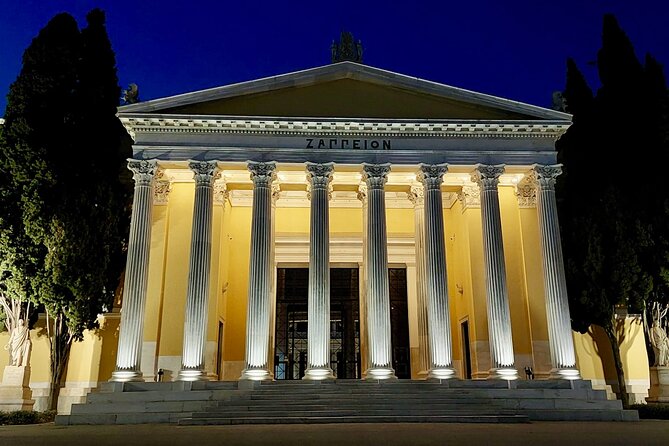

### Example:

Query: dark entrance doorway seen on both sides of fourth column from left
xmin=274 ymin=268 xmax=361 ymax=380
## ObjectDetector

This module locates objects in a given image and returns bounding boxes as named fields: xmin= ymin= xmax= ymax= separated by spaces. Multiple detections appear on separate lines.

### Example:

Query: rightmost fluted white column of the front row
xmin=532 ymin=164 xmax=580 ymax=379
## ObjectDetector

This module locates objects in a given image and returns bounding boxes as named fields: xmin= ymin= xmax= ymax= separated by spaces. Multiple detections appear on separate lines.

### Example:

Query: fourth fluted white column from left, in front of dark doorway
xmin=304 ymin=163 xmax=334 ymax=380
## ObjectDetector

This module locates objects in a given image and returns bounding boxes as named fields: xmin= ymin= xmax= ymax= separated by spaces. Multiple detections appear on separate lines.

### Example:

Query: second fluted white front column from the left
xmin=177 ymin=160 xmax=218 ymax=381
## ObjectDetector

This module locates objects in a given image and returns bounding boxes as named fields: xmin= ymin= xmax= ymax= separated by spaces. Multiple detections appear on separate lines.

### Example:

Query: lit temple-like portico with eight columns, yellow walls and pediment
xmin=112 ymin=62 xmax=579 ymax=381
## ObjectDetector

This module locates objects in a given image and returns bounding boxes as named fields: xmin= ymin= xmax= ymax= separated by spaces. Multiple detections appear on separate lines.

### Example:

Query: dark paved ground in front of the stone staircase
xmin=0 ymin=420 xmax=669 ymax=446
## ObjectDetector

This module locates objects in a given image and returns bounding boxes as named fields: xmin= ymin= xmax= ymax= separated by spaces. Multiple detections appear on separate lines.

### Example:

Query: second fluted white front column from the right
xmin=472 ymin=164 xmax=518 ymax=379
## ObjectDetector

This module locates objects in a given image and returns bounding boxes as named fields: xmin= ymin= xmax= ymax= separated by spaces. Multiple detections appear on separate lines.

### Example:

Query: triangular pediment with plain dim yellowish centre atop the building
xmin=119 ymin=62 xmax=571 ymax=120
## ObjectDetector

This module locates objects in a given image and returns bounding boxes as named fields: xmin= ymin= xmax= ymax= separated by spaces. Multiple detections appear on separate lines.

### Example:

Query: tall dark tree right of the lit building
xmin=558 ymin=15 xmax=667 ymax=405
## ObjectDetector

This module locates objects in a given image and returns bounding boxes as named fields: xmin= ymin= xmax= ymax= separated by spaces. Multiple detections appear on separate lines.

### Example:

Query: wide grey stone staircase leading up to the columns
xmin=56 ymin=380 xmax=638 ymax=425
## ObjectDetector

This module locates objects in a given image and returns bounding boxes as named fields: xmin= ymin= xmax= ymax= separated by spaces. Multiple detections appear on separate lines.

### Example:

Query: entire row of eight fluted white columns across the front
xmin=112 ymin=160 xmax=579 ymax=381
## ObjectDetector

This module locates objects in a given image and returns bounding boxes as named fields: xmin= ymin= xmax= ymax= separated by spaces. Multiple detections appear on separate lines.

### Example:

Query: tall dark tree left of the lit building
xmin=0 ymin=10 xmax=129 ymax=407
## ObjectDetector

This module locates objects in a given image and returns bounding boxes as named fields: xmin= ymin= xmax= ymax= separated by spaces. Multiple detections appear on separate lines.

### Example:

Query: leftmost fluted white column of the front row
xmin=111 ymin=159 xmax=158 ymax=382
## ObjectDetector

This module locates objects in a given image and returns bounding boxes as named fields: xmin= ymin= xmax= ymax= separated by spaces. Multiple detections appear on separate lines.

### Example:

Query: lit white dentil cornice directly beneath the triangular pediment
xmin=119 ymin=113 xmax=571 ymax=139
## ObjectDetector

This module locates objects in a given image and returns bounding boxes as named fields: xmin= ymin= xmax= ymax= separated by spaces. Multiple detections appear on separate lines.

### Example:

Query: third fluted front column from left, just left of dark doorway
xmin=240 ymin=161 xmax=276 ymax=380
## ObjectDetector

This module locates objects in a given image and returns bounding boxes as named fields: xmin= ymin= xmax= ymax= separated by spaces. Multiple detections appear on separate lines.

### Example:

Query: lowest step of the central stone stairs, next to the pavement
xmin=178 ymin=414 xmax=529 ymax=426
